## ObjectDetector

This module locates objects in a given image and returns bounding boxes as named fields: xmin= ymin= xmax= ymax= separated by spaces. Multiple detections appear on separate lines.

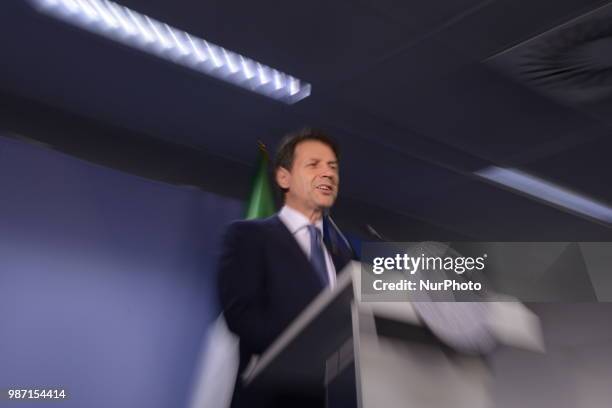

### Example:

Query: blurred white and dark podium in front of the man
xmin=243 ymin=262 xmax=541 ymax=408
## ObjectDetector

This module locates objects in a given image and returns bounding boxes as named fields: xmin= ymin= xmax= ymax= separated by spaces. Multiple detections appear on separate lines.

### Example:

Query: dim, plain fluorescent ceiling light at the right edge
xmin=474 ymin=166 xmax=612 ymax=225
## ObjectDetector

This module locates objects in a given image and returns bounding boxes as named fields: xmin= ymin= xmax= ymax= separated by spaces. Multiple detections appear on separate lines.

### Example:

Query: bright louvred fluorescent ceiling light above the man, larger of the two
xmin=30 ymin=0 xmax=310 ymax=104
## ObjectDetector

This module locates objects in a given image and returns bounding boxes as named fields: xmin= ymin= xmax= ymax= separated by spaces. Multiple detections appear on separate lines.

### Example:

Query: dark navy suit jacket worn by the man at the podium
xmin=218 ymin=215 xmax=350 ymax=407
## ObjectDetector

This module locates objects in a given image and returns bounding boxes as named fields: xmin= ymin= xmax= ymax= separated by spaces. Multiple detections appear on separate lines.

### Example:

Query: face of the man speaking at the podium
xmin=276 ymin=140 xmax=340 ymax=213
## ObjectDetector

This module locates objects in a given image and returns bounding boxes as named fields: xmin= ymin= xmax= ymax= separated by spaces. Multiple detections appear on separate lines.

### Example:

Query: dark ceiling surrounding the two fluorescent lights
xmin=0 ymin=0 xmax=612 ymax=241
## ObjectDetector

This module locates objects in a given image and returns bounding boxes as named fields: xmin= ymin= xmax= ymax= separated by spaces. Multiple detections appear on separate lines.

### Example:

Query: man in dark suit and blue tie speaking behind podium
xmin=219 ymin=129 xmax=351 ymax=407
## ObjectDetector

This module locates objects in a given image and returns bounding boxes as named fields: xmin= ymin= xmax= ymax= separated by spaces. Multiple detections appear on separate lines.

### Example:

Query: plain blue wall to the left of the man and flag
xmin=0 ymin=136 xmax=242 ymax=408
